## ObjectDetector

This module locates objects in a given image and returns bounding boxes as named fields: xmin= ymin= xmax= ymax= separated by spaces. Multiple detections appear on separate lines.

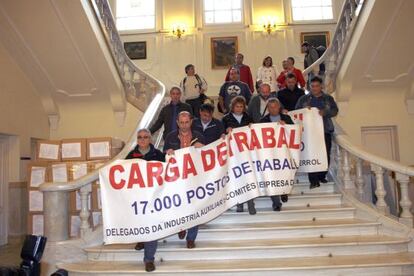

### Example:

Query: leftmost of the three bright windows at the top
xmin=116 ymin=0 xmax=155 ymax=31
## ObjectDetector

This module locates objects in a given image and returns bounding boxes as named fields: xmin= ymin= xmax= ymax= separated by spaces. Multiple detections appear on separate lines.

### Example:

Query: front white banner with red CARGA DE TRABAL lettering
xmin=99 ymin=124 xmax=300 ymax=244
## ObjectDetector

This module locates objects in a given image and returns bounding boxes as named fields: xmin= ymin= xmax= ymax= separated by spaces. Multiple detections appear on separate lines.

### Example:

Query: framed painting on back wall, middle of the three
xmin=211 ymin=36 xmax=239 ymax=69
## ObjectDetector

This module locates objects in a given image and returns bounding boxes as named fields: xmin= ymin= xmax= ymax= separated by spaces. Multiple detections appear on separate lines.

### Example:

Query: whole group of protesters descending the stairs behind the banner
xmin=127 ymin=49 xmax=338 ymax=271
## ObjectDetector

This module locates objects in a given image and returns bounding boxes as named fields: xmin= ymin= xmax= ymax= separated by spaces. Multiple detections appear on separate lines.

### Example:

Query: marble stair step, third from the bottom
xmin=166 ymin=219 xmax=381 ymax=241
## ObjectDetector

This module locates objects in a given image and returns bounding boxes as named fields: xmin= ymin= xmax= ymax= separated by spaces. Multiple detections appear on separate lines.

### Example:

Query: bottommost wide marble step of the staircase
xmin=58 ymin=253 xmax=414 ymax=276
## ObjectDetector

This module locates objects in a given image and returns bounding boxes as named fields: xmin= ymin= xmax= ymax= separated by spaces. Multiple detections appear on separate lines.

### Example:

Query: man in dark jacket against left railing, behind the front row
xmin=150 ymin=86 xmax=193 ymax=140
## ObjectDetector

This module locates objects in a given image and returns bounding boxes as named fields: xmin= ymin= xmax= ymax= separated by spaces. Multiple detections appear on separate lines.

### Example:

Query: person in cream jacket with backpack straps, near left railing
xmin=180 ymin=64 xmax=208 ymax=118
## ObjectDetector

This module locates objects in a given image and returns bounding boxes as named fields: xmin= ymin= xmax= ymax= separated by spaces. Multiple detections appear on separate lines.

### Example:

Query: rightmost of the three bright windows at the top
xmin=291 ymin=0 xmax=333 ymax=21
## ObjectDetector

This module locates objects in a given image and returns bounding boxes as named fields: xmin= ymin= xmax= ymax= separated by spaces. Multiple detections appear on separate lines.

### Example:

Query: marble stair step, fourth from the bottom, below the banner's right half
xmin=213 ymin=205 xmax=355 ymax=223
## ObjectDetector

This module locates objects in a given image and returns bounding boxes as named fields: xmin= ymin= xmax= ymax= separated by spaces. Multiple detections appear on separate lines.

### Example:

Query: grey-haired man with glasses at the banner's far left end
xmin=125 ymin=129 xmax=165 ymax=272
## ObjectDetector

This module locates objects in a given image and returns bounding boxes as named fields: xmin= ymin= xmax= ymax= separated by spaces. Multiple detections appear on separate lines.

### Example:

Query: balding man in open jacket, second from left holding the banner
xmin=164 ymin=111 xmax=204 ymax=249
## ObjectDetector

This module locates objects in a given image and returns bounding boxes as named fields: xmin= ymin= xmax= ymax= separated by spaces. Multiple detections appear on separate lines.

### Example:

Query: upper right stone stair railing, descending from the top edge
xmin=302 ymin=0 xmax=364 ymax=92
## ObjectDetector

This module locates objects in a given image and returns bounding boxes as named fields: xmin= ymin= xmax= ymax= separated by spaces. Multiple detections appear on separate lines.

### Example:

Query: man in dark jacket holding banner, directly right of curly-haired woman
xmin=260 ymin=98 xmax=293 ymax=211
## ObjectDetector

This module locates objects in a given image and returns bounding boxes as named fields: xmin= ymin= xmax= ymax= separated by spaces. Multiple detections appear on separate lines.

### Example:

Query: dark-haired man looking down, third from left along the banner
xmin=192 ymin=104 xmax=224 ymax=145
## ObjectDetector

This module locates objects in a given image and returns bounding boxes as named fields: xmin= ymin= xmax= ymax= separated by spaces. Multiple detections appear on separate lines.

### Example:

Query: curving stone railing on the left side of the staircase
xmin=40 ymin=0 xmax=165 ymax=241
